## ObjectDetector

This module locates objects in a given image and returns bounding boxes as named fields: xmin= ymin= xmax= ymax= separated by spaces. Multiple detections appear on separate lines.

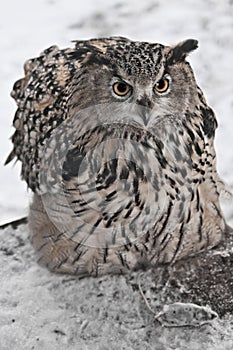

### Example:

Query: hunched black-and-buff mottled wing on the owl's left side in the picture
xmin=6 ymin=46 xmax=87 ymax=192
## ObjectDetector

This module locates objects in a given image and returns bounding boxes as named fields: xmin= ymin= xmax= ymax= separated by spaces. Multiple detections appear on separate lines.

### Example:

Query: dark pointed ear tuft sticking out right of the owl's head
xmin=168 ymin=39 xmax=198 ymax=64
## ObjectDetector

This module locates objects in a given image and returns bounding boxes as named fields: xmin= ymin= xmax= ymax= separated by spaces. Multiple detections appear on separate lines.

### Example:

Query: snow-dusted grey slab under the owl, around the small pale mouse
xmin=0 ymin=225 xmax=233 ymax=350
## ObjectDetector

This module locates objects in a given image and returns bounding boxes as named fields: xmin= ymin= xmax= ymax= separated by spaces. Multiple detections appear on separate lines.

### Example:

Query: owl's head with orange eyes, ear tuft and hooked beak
xmin=68 ymin=38 xmax=198 ymax=131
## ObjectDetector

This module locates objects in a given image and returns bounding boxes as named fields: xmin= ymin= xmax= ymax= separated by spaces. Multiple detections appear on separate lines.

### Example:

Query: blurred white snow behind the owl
xmin=0 ymin=0 xmax=233 ymax=224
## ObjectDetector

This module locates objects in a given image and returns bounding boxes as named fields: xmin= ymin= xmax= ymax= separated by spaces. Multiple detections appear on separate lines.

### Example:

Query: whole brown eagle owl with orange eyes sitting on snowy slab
xmin=7 ymin=37 xmax=226 ymax=276
